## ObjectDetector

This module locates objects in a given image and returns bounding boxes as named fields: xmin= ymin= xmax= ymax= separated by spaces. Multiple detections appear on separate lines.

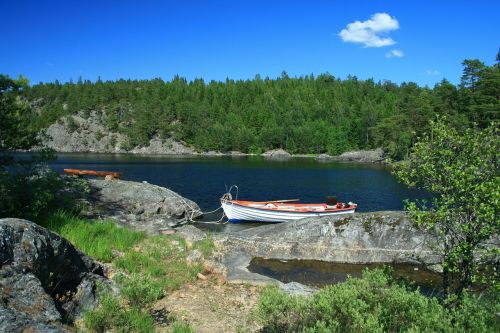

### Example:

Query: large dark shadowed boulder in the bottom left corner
xmin=0 ymin=218 xmax=109 ymax=332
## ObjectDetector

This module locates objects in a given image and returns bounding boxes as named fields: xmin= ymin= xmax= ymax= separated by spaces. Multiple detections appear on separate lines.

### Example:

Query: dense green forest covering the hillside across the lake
xmin=23 ymin=52 xmax=500 ymax=159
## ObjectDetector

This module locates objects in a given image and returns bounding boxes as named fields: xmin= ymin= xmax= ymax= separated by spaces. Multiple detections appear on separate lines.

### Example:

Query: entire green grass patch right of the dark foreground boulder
xmin=40 ymin=211 xmax=214 ymax=333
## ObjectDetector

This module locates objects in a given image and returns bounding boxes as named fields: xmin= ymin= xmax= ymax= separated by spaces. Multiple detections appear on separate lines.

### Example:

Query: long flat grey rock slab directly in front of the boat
xmin=219 ymin=211 xmax=441 ymax=281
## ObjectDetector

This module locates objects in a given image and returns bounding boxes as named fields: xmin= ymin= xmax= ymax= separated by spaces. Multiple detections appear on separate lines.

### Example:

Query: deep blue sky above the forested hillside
xmin=0 ymin=0 xmax=500 ymax=86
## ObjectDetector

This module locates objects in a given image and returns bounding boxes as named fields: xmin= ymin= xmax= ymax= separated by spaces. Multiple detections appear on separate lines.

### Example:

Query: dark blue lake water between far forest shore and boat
xmin=47 ymin=153 xmax=422 ymax=212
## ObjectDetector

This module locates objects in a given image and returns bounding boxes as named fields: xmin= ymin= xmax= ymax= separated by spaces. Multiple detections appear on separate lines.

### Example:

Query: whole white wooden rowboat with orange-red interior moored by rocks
xmin=221 ymin=197 xmax=357 ymax=222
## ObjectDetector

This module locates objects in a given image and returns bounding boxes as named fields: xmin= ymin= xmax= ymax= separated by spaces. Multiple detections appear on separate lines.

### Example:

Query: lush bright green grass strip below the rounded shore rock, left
xmin=40 ymin=211 xmax=145 ymax=262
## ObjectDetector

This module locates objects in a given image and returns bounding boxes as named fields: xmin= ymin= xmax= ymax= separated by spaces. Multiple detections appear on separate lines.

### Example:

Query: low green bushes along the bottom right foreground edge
xmin=258 ymin=270 xmax=500 ymax=332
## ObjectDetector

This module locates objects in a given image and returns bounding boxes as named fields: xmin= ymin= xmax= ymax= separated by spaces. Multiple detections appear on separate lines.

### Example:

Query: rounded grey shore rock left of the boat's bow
xmin=87 ymin=179 xmax=201 ymax=234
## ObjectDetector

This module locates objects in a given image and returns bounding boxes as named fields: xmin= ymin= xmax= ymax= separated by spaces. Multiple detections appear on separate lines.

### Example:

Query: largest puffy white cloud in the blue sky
xmin=339 ymin=13 xmax=399 ymax=47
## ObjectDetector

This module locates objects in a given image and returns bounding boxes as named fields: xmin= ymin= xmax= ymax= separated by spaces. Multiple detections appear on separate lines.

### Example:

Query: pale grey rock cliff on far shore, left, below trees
xmin=43 ymin=111 xmax=194 ymax=155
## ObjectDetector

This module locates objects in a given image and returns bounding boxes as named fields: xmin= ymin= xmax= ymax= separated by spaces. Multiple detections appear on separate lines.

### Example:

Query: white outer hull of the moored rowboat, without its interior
xmin=222 ymin=201 xmax=356 ymax=223
